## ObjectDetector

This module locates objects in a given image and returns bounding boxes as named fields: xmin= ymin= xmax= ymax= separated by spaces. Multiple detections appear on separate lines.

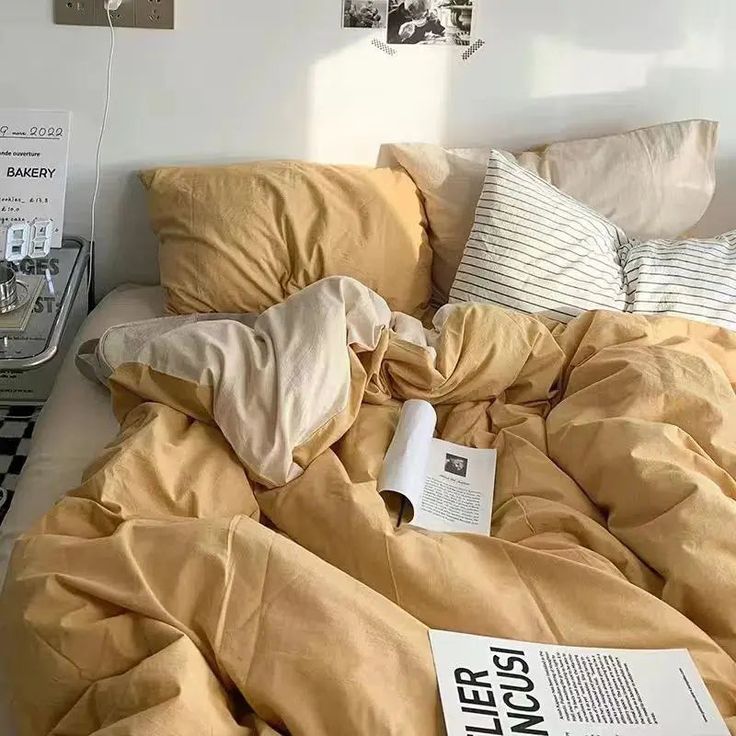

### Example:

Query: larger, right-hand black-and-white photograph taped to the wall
xmin=387 ymin=0 xmax=473 ymax=46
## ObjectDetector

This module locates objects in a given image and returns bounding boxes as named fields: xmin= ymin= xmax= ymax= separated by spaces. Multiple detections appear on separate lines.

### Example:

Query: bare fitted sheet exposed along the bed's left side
xmin=0 ymin=286 xmax=164 ymax=736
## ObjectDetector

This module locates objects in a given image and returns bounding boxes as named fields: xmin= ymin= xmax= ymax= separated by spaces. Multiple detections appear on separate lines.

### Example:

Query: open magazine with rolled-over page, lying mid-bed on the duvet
xmin=378 ymin=400 xmax=496 ymax=534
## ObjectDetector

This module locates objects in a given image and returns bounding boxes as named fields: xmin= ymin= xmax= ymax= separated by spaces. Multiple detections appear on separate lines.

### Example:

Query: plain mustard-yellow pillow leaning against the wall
xmin=141 ymin=161 xmax=432 ymax=315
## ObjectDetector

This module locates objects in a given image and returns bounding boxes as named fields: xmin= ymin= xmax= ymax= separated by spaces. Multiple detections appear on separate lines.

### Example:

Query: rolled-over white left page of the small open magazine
xmin=378 ymin=400 xmax=437 ymax=521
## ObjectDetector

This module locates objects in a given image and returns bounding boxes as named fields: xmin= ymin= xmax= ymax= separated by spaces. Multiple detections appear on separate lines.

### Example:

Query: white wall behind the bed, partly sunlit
xmin=0 ymin=0 xmax=736 ymax=293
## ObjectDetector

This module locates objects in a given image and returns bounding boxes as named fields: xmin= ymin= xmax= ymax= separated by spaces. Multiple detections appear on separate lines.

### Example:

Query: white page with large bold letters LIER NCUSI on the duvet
xmin=429 ymin=631 xmax=729 ymax=736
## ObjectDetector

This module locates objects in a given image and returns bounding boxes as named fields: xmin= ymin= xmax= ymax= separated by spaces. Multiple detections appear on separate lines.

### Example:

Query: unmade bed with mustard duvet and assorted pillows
xmin=0 ymin=121 xmax=736 ymax=736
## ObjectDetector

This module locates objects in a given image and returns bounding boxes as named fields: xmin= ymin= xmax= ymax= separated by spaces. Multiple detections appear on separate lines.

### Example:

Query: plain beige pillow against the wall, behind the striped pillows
xmin=379 ymin=120 xmax=718 ymax=304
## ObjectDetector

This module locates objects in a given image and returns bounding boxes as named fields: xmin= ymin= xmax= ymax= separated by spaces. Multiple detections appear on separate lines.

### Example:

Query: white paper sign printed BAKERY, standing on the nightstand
xmin=0 ymin=110 xmax=71 ymax=248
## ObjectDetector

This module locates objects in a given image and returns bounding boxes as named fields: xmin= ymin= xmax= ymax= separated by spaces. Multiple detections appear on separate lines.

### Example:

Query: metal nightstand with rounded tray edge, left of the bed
xmin=0 ymin=238 xmax=90 ymax=405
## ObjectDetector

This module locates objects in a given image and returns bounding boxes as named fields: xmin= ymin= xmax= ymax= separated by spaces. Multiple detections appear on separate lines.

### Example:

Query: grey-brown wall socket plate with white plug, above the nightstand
xmin=54 ymin=0 xmax=174 ymax=30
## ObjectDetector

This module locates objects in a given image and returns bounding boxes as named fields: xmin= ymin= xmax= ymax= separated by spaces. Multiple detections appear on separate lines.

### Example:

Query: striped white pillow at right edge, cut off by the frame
xmin=622 ymin=231 xmax=736 ymax=330
